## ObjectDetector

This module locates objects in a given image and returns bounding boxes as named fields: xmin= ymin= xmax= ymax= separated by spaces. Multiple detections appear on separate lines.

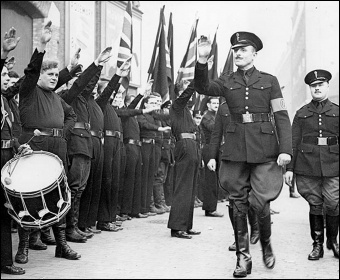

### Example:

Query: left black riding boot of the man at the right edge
xmin=308 ymin=213 xmax=324 ymax=261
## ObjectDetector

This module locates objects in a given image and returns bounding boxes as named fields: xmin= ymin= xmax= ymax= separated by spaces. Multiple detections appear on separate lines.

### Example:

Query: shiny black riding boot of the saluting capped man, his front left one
xmin=233 ymin=209 xmax=252 ymax=277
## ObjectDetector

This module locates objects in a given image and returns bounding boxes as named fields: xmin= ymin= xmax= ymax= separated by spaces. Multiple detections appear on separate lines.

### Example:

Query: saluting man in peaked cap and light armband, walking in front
xmin=195 ymin=32 xmax=292 ymax=277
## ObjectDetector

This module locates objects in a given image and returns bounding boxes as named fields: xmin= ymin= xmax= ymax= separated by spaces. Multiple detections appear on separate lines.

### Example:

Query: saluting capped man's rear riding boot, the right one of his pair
xmin=257 ymin=208 xmax=275 ymax=269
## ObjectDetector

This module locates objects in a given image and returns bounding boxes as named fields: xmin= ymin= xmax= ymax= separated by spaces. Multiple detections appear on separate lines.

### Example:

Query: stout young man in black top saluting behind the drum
xmin=18 ymin=21 xmax=81 ymax=262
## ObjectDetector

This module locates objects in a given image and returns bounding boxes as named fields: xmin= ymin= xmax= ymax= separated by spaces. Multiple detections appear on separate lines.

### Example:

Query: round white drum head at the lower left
xmin=1 ymin=151 xmax=63 ymax=193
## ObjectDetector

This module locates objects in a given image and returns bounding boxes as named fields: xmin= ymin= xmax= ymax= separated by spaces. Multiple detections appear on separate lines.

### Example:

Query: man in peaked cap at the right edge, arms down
xmin=285 ymin=69 xmax=339 ymax=260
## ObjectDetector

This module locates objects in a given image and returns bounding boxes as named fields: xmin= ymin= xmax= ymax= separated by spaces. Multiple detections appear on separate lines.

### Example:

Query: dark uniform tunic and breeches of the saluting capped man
xmin=195 ymin=63 xmax=292 ymax=213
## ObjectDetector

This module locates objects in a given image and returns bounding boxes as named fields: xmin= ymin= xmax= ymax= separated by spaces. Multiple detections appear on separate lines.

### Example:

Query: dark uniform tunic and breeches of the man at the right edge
xmin=287 ymin=99 xmax=339 ymax=216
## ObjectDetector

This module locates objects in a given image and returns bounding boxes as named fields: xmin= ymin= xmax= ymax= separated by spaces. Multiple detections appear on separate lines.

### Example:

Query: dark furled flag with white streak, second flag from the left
xmin=148 ymin=6 xmax=172 ymax=103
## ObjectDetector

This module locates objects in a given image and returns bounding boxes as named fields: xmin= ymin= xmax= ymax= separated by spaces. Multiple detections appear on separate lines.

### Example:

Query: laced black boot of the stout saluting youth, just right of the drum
xmin=52 ymin=225 xmax=81 ymax=260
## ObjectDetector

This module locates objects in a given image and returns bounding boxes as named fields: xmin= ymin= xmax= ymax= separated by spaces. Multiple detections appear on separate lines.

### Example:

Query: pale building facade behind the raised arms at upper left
xmin=1 ymin=1 xmax=142 ymax=95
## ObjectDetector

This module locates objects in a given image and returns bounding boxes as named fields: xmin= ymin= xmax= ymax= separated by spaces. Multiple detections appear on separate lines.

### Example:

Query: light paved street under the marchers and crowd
xmin=1 ymin=186 xmax=339 ymax=279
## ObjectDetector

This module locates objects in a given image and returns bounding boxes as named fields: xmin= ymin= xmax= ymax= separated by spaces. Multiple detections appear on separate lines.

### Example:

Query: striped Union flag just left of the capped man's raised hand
xmin=176 ymin=18 xmax=198 ymax=83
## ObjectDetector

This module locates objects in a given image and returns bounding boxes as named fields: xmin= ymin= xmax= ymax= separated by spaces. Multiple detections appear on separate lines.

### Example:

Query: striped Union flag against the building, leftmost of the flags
xmin=117 ymin=1 xmax=133 ymax=94
